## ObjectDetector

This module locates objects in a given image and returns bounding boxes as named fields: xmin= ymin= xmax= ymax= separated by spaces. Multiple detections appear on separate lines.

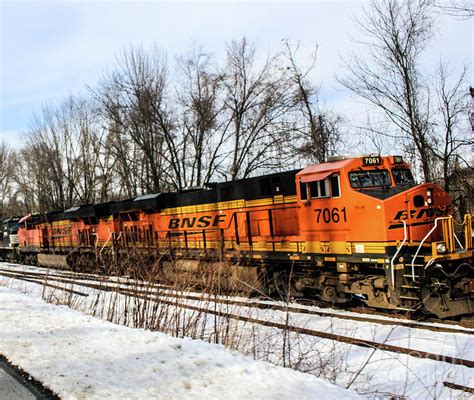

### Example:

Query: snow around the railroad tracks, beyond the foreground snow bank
xmin=0 ymin=263 xmax=474 ymax=399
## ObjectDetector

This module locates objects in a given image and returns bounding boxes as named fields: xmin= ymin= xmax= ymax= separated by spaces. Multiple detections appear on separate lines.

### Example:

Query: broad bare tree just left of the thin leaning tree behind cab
xmin=220 ymin=38 xmax=294 ymax=180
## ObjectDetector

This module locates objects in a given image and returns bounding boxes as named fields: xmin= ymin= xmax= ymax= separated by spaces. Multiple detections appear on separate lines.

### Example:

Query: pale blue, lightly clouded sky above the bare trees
xmin=0 ymin=0 xmax=474 ymax=146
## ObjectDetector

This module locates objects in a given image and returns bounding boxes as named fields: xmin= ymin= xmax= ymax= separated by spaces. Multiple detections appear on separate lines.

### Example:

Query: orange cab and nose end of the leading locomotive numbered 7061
xmin=296 ymin=156 xmax=474 ymax=317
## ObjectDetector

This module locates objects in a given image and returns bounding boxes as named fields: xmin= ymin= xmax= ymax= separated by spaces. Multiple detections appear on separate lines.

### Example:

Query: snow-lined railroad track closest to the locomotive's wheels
xmin=0 ymin=269 xmax=474 ymax=335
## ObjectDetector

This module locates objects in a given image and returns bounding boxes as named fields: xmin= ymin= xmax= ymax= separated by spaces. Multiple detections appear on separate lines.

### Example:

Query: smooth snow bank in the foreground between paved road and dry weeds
xmin=0 ymin=287 xmax=358 ymax=399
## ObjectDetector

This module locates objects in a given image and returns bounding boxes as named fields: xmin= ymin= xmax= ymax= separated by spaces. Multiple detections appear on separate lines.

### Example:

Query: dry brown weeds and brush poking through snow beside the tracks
xmin=2 ymin=254 xmax=460 ymax=398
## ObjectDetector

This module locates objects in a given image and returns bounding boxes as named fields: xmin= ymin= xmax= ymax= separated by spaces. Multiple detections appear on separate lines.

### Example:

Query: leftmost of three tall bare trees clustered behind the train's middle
xmin=94 ymin=48 xmax=174 ymax=195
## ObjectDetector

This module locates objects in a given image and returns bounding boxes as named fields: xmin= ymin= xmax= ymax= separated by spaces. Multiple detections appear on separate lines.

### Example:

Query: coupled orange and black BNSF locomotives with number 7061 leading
xmin=3 ymin=156 xmax=474 ymax=318
